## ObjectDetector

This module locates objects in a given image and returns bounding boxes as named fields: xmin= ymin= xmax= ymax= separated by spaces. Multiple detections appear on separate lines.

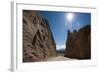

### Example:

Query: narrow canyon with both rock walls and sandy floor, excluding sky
xmin=22 ymin=10 xmax=91 ymax=62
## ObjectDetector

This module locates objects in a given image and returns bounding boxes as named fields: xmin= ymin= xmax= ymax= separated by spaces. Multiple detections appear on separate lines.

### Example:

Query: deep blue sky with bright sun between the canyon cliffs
xmin=40 ymin=11 xmax=91 ymax=50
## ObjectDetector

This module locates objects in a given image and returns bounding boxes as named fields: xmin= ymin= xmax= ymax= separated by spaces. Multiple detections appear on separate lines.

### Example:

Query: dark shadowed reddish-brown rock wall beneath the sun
xmin=64 ymin=25 xmax=91 ymax=59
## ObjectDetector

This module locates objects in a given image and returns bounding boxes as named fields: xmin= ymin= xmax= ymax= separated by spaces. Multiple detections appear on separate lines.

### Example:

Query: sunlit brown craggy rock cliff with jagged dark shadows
xmin=23 ymin=10 xmax=56 ymax=62
